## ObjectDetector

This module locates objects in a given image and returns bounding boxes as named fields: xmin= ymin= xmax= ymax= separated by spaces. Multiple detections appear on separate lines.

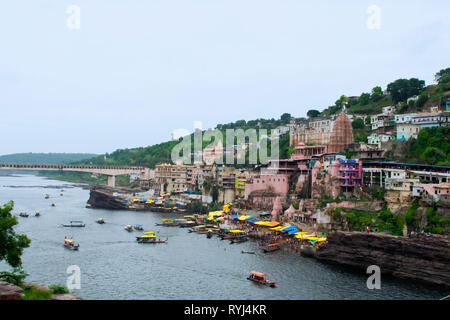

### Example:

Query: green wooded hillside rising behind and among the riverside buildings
xmin=74 ymin=68 xmax=450 ymax=167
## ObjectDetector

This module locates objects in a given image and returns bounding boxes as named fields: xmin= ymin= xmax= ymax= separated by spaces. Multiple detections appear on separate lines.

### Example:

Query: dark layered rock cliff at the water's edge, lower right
xmin=316 ymin=232 xmax=450 ymax=287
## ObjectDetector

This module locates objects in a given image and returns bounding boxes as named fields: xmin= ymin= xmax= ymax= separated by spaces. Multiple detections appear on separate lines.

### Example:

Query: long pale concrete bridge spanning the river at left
xmin=0 ymin=164 xmax=150 ymax=187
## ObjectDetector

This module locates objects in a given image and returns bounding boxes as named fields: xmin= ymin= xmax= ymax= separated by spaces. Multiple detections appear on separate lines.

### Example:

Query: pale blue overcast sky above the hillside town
xmin=0 ymin=0 xmax=450 ymax=155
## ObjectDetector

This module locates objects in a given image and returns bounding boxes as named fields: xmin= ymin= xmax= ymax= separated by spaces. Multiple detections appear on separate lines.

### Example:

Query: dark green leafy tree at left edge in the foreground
xmin=0 ymin=201 xmax=31 ymax=268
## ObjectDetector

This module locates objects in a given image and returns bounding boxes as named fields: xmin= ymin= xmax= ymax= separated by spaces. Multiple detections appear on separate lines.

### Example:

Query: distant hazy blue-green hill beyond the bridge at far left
xmin=0 ymin=152 xmax=97 ymax=165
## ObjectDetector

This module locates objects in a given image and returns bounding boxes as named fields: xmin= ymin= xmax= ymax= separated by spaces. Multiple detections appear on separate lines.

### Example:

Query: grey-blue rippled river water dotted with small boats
xmin=0 ymin=175 xmax=448 ymax=300
